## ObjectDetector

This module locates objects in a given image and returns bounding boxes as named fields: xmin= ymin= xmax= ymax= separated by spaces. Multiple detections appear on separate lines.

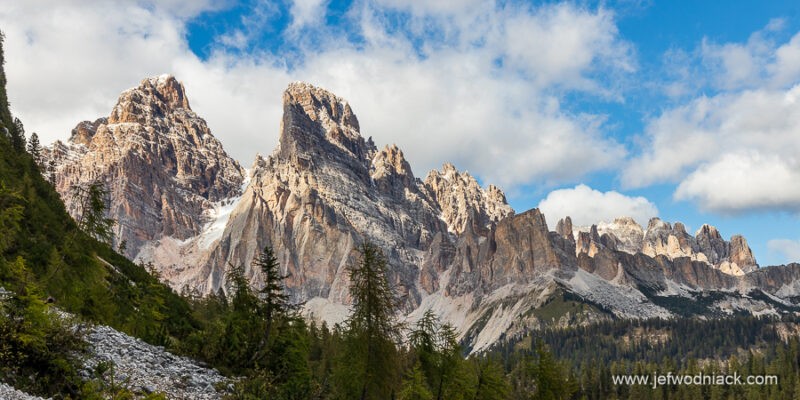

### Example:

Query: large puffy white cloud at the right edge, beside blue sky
xmin=621 ymin=23 xmax=800 ymax=213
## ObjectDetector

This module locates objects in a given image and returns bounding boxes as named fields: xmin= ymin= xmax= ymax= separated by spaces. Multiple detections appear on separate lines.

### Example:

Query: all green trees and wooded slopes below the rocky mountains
xmin=0 ymin=33 xmax=800 ymax=400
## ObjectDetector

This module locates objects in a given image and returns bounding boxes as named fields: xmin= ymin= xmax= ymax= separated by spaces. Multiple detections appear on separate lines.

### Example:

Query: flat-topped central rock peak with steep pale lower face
xmin=183 ymin=83 xmax=446 ymax=307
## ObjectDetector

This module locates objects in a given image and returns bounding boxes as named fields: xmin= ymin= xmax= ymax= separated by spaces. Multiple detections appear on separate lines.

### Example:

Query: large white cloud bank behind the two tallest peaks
xmin=0 ymin=0 xmax=635 ymax=187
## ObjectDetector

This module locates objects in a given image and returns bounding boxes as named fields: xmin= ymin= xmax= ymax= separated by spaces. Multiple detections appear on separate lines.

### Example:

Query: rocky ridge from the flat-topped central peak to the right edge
xmin=42 ymin=78 xmax=800 ymax=350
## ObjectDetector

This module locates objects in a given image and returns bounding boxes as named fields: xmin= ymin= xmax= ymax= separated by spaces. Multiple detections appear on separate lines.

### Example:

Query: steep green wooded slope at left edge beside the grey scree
xmin=0 ymin=28 xmax=197 ymax=398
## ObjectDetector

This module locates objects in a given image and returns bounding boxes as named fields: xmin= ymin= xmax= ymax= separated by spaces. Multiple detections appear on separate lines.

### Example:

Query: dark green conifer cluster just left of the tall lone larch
xmin=184 ymin=248 xmax=314 ymax=399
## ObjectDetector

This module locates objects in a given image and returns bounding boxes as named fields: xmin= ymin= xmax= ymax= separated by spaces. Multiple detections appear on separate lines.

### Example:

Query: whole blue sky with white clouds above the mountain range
xmin=0 ymin=0 xmax=800 ymax=265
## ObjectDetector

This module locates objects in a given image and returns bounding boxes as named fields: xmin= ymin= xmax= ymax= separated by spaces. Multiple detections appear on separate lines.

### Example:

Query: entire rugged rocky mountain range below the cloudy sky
xmin=43 ymin=75 xmax=800 ymax=351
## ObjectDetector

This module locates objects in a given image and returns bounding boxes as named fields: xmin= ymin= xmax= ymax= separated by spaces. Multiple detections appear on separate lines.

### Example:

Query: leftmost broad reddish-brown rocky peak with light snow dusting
xmin=44 ymin=75 xmax=243 ymax=257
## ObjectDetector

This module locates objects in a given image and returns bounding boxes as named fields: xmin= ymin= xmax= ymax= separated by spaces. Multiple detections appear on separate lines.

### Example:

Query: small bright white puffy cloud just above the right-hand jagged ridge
xmin=538 ymin=184 xmax=658 ymax=226
